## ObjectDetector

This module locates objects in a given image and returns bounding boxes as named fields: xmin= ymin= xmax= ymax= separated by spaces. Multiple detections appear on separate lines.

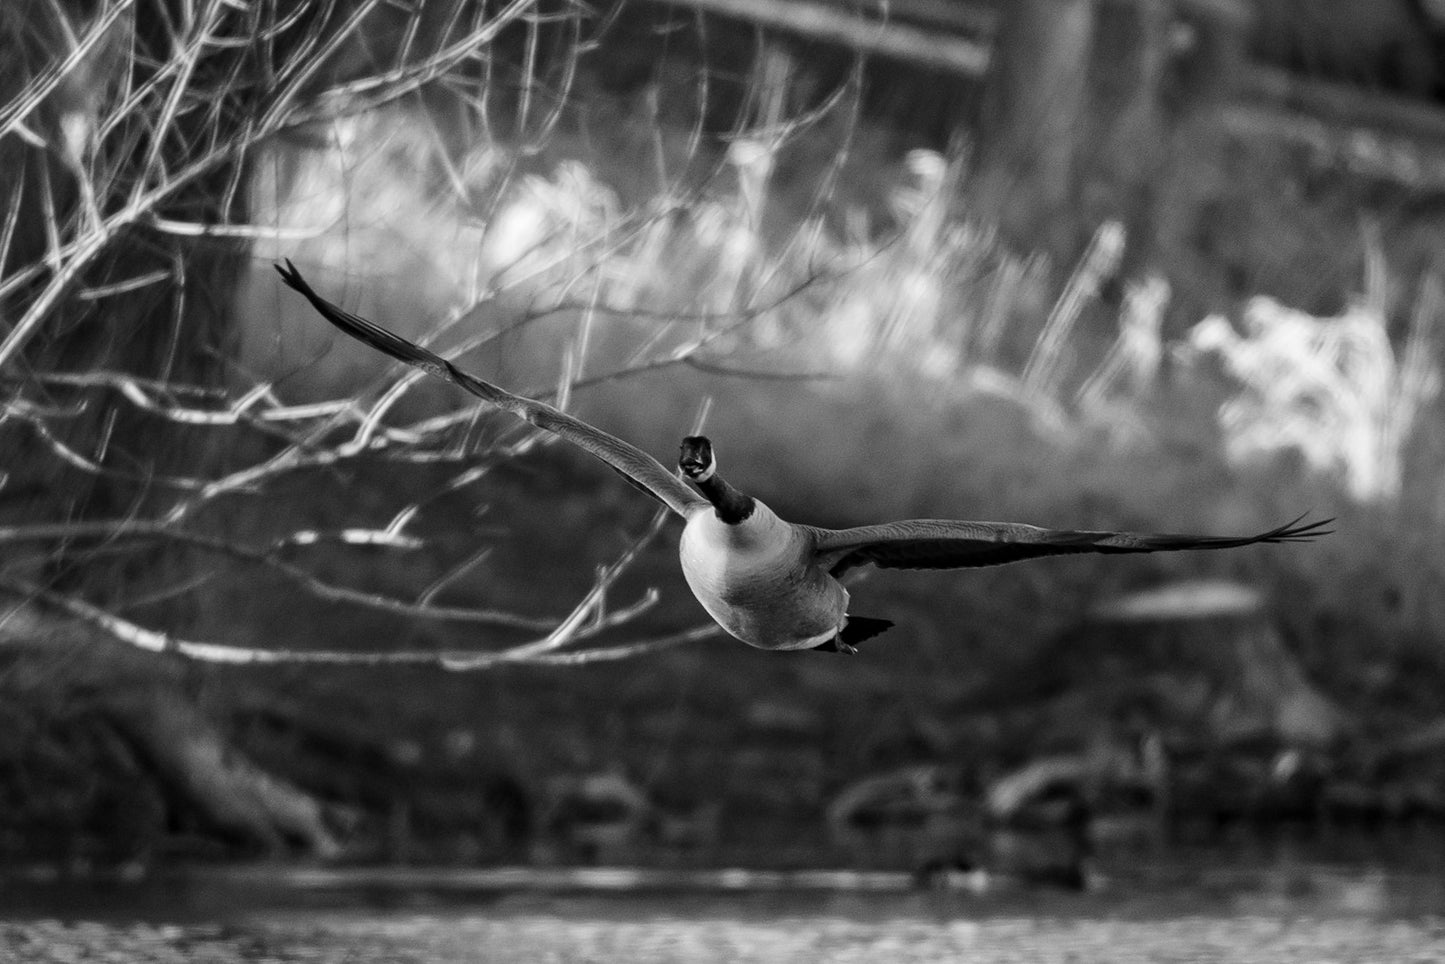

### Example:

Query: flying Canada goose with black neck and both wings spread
xmin=276 ymin=260 xmax=1331 ymax=653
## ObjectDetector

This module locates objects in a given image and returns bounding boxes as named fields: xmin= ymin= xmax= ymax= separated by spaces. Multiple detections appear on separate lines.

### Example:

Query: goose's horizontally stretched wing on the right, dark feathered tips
xmin=814 ymin=516 xmax=1334 ymax=575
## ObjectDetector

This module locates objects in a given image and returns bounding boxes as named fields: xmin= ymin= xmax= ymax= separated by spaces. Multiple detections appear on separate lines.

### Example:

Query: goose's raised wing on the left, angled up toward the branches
xmin=276 ymin=260 xmax=707 ymax=516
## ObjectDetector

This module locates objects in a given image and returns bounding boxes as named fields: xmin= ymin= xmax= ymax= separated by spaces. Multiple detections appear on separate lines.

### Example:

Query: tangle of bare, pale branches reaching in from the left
xmin=0 ymin=0 xmax=745 ymax=671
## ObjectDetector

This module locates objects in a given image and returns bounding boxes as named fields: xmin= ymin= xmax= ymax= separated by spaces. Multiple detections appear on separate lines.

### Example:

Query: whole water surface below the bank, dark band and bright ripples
xmin=8 ymin=866 xmax=1445 ymax=964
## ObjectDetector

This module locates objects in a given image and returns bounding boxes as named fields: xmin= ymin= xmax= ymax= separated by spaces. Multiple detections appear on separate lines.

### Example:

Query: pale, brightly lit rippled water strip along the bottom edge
xmin=8 ymin=913 xmax=1445 ymax=964
